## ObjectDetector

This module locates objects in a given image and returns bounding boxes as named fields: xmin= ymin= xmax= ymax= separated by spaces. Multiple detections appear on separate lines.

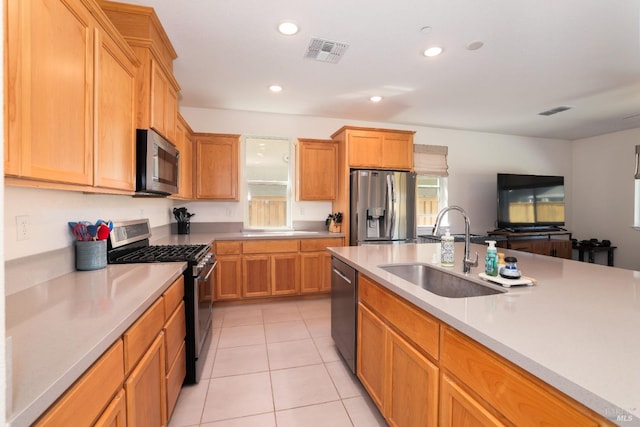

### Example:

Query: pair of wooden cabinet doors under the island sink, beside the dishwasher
xmin=357 ymin=304 xmax=438 ymax=427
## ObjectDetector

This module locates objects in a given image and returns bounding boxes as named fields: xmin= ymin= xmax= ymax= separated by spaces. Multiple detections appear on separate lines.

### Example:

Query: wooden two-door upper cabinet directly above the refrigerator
xmin=332 ymin=126 xmax=415 ymax=170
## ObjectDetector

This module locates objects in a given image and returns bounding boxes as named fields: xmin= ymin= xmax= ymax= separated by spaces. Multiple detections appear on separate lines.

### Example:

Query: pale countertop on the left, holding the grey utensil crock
xmin=6 ymin=262 xmax=186 ymax=426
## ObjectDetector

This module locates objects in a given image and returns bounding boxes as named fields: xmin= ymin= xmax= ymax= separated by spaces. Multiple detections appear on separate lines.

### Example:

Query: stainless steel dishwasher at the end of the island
xmin=331 ymin=257 xmax=358 ymax=374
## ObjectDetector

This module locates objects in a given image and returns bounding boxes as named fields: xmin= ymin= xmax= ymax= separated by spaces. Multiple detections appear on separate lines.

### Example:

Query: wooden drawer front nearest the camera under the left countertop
xmin=35 ymin=339 xmax=124 ymax=427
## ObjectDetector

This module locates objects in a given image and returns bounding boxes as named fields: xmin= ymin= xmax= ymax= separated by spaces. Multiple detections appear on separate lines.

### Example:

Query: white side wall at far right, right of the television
xmin=571 ymin=128 xmax=640 ymax=270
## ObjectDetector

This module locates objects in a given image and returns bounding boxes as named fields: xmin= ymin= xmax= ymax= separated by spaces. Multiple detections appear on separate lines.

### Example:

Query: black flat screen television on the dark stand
xmin=497 ymin=173 xmax=565 ymax=231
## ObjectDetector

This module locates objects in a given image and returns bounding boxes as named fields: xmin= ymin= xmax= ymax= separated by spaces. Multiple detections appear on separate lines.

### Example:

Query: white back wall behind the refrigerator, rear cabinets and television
xmin=180 ymin=107 xmax=571 ymax=234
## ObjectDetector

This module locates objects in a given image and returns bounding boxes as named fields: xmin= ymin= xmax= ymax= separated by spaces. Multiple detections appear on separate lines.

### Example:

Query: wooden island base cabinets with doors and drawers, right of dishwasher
xmin=357 ymin=275 xmax=614 ymax=427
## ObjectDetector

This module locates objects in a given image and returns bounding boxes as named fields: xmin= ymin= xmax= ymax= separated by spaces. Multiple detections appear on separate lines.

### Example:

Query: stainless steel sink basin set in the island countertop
xmin=379 ymin=263 xmax=507 ymax=298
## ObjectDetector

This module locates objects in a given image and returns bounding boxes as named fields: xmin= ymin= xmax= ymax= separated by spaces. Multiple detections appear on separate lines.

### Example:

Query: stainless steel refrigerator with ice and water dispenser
xmin=349 ymin=170 xmax=416 ymax=246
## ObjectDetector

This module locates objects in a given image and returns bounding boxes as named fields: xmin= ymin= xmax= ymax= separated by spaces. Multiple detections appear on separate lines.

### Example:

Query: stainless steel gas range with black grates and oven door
xmin=107 ymin=219 xmax=216 ymax=384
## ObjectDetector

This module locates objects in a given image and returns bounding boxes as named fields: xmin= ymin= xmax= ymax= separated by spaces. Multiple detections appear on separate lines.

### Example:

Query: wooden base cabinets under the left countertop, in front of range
xmin=34 ymin=276 xmax=186 ymax=427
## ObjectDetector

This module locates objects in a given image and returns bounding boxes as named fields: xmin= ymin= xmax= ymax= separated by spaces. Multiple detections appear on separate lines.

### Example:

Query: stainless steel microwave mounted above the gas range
xmin=136 ymin=129 xmax=180 ymax=196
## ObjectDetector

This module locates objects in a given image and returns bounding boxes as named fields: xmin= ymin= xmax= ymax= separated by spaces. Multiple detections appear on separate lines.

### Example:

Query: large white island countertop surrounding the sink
xmin=329 ymin=243 xmax=640 ymax=426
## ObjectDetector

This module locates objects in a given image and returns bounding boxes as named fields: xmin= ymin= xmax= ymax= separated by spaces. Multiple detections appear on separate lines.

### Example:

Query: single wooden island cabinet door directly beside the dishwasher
xmin=356 ymin=304 xmax=387 ymax=413
